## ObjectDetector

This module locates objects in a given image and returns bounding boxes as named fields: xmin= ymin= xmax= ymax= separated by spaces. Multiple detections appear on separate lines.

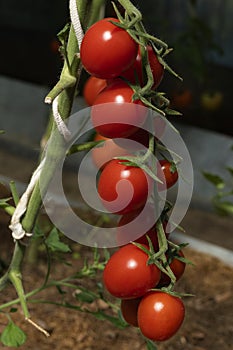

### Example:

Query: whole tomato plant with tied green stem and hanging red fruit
xmin=0 ymin=0 xmax=192 ymax=349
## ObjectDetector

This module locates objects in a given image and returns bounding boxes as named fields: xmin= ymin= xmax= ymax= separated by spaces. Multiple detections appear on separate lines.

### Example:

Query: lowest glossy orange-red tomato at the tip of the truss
xmin=138 ymin=291 xmax=185 ymax=341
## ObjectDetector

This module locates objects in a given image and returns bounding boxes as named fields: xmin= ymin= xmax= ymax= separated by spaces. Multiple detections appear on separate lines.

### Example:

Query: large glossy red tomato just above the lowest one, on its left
xmin=103 ymin=244 xmax=161 ymax=299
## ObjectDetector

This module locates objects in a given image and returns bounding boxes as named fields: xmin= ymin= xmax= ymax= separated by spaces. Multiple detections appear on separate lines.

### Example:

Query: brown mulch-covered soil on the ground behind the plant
xmin=0 ymin=148 xmax=233 ymax=350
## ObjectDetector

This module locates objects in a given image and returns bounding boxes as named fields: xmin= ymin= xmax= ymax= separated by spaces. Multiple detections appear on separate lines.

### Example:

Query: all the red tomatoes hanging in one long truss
xmin=80 ymin=18 xmax=185 ymax=341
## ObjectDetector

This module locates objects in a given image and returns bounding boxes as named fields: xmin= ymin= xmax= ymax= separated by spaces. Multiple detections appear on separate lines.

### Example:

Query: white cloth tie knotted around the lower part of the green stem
xmin=9 ymin=158 xmax=45 ymax=240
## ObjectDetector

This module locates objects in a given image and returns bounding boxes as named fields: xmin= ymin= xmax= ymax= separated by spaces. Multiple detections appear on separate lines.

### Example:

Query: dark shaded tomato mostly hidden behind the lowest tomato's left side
xmin=121 ymin=298 xmax=141 ymax=327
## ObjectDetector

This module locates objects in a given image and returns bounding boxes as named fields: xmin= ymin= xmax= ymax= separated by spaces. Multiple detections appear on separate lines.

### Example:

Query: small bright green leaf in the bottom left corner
xmin=0 ymin=320 xmax=27 ymax=347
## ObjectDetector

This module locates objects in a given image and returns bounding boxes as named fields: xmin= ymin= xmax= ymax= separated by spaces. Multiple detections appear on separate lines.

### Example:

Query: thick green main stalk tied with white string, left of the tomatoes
xmin=0 ymin=0 xmax=104 ymax=330
